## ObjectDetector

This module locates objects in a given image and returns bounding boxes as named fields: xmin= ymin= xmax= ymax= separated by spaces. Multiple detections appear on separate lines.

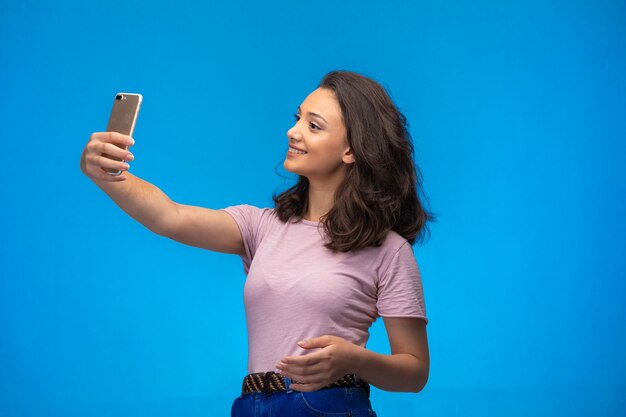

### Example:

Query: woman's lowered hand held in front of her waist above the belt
xmin=276 ymin=335 xmax=360 ymax=392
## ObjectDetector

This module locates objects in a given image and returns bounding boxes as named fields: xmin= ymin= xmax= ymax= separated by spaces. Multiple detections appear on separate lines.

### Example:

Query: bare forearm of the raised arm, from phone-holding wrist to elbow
xmin=93 ymin=172 xmax=176 ymax=235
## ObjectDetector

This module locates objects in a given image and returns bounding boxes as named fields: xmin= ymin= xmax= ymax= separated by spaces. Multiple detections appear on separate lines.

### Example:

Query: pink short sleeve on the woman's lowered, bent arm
xmin=376 ymin=242 xmax=428 ymax=323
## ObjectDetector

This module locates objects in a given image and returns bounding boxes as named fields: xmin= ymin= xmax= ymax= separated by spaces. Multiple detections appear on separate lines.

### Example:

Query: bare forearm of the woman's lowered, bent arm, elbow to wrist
xmin=354 ymin=346 xmax=428 ymax=392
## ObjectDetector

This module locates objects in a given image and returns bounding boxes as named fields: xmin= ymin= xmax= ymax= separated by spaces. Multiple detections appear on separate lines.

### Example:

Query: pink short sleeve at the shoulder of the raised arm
xmin=220 ymin=204 xmax=271 ymax=274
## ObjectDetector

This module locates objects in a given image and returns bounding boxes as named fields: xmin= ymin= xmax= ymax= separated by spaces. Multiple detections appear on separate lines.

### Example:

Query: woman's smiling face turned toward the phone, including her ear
xmin=284 ymin=88 xmax=354 ymax=181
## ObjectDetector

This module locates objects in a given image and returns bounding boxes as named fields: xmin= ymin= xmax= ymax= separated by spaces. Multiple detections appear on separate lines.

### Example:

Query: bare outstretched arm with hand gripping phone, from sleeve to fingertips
xmin=80 ymin=132 xmax=244 ymax=254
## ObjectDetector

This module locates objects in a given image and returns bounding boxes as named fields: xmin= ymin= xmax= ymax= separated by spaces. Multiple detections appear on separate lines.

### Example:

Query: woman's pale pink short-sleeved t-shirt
xmin=217 ymin=204 xmax=428 ymax=373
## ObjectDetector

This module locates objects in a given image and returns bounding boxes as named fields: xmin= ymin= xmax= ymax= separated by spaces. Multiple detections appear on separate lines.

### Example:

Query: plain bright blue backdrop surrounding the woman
xmin=0 ymin=0 xmax=626 ymax=416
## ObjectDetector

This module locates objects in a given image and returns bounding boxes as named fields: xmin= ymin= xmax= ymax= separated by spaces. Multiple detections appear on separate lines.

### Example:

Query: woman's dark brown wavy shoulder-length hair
xmin=272 ymin=71 xmax=435 ymax=252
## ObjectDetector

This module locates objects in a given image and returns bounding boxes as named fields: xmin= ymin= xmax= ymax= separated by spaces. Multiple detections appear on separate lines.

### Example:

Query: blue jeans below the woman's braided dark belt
xmin=231 ymin=378 xmax=376 ymax=417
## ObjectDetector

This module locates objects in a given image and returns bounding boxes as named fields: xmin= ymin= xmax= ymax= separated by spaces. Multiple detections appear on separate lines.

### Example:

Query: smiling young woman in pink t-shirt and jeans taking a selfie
xmin=81 ymin=71 xmax=434 ymax=417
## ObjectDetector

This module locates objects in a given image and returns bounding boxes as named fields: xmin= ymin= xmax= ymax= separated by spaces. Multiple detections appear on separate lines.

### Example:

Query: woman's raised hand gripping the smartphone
xmin=80 ymin=132 xmax=135 ymax=182
